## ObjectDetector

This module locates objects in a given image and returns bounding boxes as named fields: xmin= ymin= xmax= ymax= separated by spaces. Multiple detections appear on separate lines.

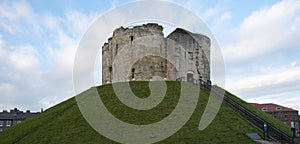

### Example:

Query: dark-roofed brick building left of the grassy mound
xmin=0 ymin=108 xmax=38 ymax=132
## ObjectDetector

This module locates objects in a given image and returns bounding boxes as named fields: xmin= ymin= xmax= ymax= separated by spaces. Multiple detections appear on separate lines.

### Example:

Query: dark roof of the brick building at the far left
xmin=0 ymin=108 xmax=38 ymax=120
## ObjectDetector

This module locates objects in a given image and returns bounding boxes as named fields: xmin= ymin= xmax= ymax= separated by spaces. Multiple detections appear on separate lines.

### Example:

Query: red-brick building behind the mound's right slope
xmin=251 ymin=103 xmax=300 ymax=132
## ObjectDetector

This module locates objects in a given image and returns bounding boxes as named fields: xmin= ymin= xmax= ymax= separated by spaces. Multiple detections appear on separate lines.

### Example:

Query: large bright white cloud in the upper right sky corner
xmin=223 ymin=0 xmax=300 ymax=62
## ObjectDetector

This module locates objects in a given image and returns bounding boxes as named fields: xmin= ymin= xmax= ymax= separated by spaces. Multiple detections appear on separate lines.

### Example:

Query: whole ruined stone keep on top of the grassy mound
xmin=102 ymin=23 xmax=211 ymax=84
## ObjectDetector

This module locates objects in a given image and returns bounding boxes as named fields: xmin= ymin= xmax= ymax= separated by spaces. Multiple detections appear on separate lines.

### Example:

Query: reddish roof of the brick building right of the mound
xmin=250 ymin=103 xmax=298 ymax=112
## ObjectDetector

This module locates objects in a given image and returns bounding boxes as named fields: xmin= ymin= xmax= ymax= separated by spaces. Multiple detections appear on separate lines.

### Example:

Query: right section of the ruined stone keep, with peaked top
xmin=167 ymin=29 xmax=210 ymax=81
